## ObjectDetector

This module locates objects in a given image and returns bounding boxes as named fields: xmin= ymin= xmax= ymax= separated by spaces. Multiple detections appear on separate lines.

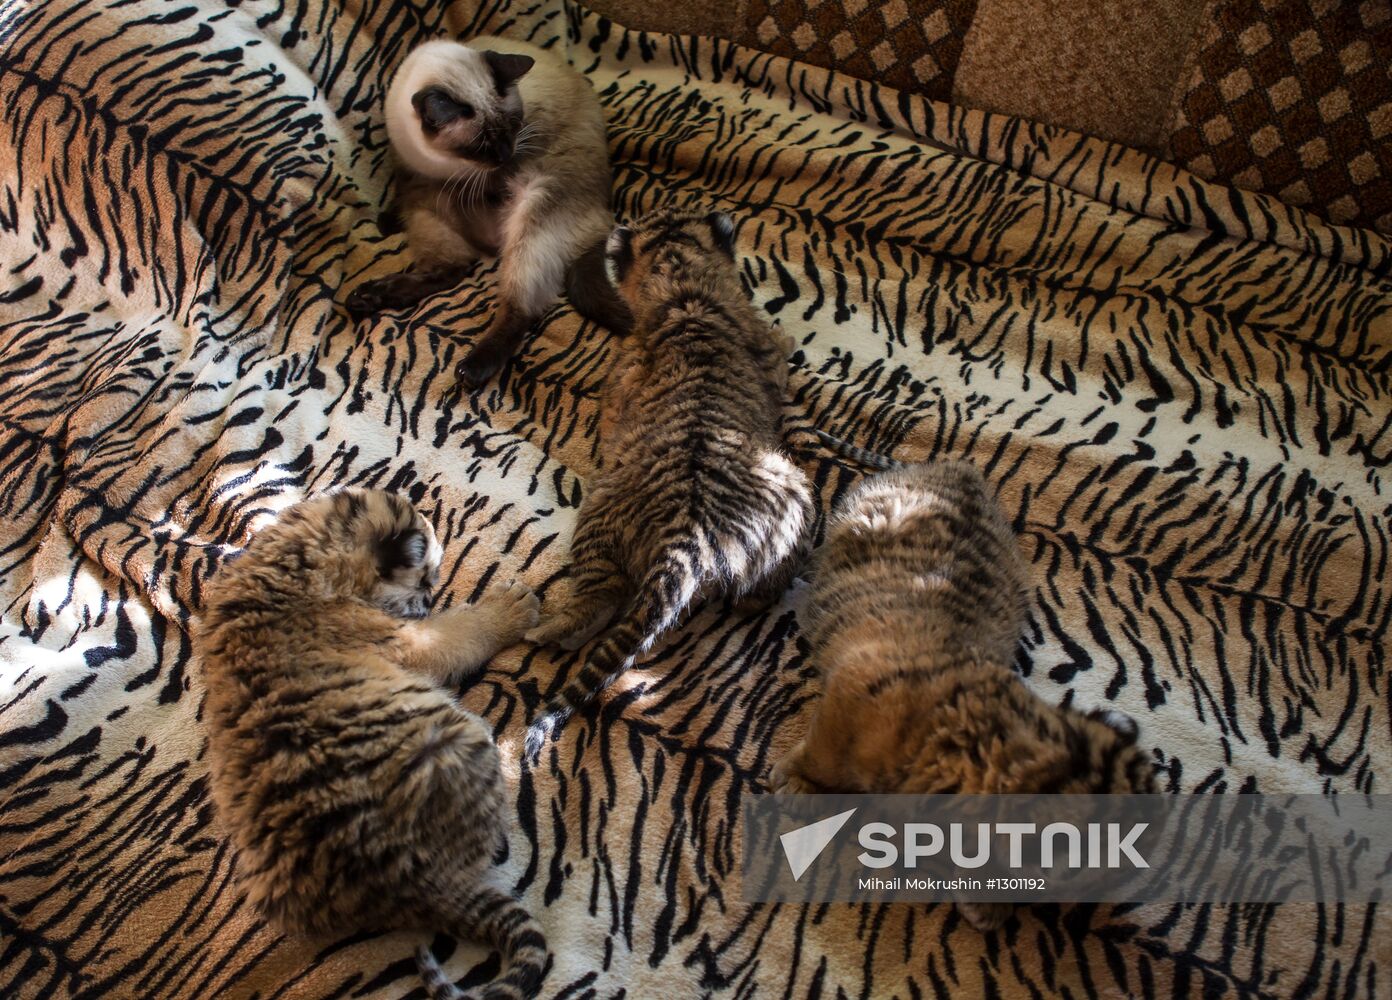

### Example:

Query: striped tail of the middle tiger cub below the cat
xmin=525 ymin=552 xmax=700 ymax=759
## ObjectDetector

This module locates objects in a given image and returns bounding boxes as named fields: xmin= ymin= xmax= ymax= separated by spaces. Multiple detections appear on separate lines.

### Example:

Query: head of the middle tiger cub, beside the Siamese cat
xmin=604 ymin=208 xmax=745 ymax=325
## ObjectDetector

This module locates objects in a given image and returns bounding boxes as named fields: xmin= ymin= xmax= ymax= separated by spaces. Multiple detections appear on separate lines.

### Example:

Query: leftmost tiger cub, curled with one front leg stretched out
xmin=195 ymin=490 xmax=547 ymax=1000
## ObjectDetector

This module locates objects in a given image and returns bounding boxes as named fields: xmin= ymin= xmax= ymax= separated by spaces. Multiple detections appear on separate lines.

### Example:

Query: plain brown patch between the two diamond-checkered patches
xmin=952 ymin=0 xmax=1204 ymax=150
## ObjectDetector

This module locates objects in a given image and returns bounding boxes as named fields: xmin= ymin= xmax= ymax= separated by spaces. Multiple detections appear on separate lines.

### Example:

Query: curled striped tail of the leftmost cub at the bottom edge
xmin=416 ymin=886 xmax=550 ymax=1000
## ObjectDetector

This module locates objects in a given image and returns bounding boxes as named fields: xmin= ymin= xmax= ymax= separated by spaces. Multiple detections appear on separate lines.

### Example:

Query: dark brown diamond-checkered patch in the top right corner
xmin=1164 ymin=0 xmax=1392 ymax=234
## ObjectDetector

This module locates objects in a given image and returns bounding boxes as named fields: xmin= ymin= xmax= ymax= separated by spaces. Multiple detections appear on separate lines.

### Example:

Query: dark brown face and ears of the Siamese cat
xmin=411 ymin=52 xmax=533 ymax=169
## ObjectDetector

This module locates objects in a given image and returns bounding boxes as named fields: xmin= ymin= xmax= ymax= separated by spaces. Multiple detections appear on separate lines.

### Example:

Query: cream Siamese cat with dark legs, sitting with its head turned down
xmin=347 ymin=38 xmax=626 ymax=389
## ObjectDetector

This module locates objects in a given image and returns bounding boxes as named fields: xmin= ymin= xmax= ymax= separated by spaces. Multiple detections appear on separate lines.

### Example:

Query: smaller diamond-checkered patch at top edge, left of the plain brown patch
xmin=738 ymin=0 xmax=977 ymax=100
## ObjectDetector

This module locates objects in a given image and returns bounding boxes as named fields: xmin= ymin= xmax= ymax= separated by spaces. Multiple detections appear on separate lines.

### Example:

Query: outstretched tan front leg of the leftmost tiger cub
xmin=401 ymin=584 xmax=540 ymax=684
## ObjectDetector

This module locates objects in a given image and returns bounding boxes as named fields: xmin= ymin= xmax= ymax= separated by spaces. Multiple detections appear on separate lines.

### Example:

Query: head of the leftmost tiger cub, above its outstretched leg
xmin=230 ymin=489 xmax=443 ymax=618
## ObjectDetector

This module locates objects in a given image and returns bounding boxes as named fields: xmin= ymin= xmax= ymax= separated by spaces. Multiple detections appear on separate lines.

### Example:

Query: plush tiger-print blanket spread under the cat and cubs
xmin=0 ymin=0 xmax=1392 ymax=1000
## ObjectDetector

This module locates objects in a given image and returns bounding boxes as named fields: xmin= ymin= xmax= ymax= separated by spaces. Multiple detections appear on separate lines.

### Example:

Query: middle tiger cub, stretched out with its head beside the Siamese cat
xmin=526 ymin=209 xmax=813 ymax=755
